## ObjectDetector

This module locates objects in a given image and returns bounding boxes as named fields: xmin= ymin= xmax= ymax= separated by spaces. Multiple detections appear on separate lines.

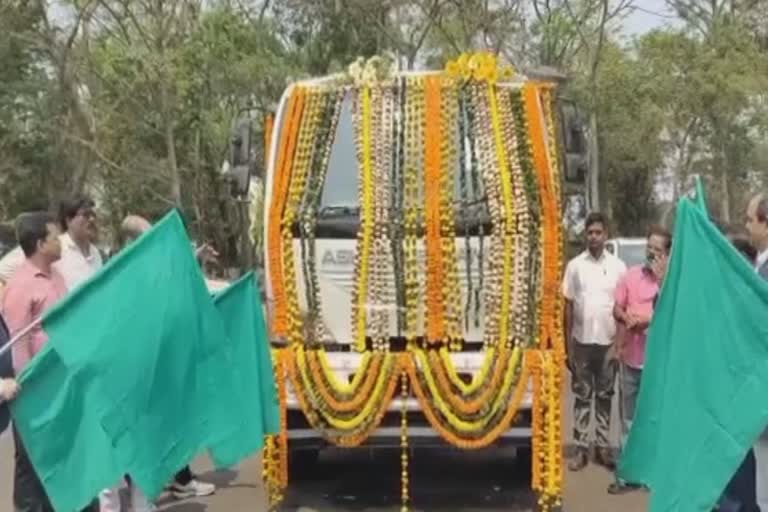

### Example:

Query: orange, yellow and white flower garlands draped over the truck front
xmin=264 ymin=54 xmax=563 ymax=510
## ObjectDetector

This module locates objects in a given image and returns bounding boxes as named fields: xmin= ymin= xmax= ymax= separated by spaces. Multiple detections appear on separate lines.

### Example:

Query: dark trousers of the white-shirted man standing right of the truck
xmin=570 ymin=341 xmax=618 ymax=450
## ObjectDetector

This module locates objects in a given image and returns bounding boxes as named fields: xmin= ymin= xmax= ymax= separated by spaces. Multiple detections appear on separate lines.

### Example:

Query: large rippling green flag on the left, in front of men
xmin=13 ymin=212 xmax=243 ymax=511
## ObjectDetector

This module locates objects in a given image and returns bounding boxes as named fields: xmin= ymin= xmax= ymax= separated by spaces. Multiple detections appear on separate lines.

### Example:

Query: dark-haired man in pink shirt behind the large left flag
xmin=2 ymin=212 xmax=67 ymax=512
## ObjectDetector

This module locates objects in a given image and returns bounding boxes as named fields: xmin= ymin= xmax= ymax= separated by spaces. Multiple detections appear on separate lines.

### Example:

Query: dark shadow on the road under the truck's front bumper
xmin=281 ymin=448 xmax=536 ymax=512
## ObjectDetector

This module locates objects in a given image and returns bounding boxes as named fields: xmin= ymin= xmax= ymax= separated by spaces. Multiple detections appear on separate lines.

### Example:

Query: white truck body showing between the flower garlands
xmin=237 ymin=64 xmax=586 ymax=467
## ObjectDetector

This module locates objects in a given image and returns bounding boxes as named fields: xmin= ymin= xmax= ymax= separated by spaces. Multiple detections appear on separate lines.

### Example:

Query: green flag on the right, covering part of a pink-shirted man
xmin=619 ymin=199 xmax=768 ymax=512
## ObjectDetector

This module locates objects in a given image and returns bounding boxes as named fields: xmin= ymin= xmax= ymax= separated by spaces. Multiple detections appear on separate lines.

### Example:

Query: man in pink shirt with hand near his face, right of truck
xmin=608 ymin=226 xmax=672 ymax=494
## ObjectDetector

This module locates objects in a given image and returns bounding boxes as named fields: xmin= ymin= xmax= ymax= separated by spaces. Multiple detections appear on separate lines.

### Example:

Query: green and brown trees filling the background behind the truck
xmin=0 ymin=0 xmax=768 ymax=265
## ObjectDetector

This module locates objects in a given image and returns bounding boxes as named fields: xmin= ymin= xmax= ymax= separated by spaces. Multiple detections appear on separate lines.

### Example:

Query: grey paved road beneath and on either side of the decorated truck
xmin=0 ymin=372 xmax=647 ymax=512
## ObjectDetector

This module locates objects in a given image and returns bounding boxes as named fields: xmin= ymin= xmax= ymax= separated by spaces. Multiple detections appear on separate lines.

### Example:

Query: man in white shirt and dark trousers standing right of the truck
xmin=562 ymin=213 xmax=627 ymax=471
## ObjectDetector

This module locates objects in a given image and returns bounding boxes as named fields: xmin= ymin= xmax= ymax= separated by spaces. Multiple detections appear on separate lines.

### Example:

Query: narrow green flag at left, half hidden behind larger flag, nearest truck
xmin=211 ymin=273 xmax=280 ymax=467
